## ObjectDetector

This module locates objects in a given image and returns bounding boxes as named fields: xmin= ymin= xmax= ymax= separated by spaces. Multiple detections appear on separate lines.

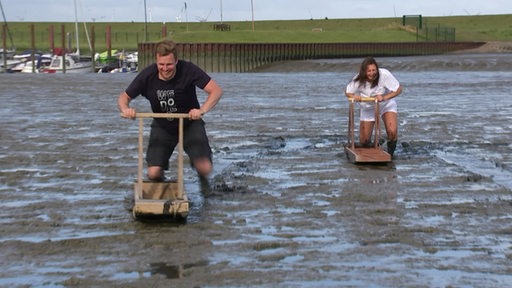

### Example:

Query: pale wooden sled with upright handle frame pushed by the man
xmin=132 ymin=113 xmax=189 ymax=219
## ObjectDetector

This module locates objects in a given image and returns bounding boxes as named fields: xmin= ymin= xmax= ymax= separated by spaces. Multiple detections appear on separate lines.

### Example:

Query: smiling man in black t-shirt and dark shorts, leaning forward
xmin=117 ymin=40 xmax=222 ymax=181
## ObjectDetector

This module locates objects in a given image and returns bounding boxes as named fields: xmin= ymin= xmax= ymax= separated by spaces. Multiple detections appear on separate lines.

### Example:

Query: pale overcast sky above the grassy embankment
xmin=0 ymin=0 xmax=512 ymax=22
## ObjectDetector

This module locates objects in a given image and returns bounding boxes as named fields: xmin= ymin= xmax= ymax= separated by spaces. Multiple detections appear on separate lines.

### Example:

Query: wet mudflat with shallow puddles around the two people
xmin=0 ymin=54 xmax=512 ymax=287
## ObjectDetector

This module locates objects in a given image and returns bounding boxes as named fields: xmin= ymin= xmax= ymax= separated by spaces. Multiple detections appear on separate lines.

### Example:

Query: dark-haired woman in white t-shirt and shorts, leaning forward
xmin=345 ymin=57 xmax=402 ymax=156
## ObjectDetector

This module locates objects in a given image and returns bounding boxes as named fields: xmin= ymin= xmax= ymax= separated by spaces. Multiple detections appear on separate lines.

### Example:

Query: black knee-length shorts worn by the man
xmin=146 ymin=120 xmax=212 ymax=170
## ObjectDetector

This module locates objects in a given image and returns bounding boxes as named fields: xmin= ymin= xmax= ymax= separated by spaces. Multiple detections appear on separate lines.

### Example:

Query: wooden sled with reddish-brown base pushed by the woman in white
xmin=345 ymin=97 xmax=391 ymax=163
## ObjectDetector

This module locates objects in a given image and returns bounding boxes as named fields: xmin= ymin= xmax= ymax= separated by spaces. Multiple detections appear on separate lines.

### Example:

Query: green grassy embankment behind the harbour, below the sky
xmin=7 ymin=14 xmax=512 ymax=54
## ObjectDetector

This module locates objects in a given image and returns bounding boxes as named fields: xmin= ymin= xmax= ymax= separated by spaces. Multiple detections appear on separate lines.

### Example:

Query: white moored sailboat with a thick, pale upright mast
xmin=43 ymin=0 xmax=94 ymax=73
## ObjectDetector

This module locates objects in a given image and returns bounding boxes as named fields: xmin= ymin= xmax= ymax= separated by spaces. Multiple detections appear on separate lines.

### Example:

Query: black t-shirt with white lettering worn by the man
xmin=125 ymin=60 xmax=211 ymax=134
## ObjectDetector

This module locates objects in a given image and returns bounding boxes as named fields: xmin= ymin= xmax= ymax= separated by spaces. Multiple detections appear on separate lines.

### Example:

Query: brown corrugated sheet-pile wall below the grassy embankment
xmin=138 ymin=42 xmax=485 ymax=72
